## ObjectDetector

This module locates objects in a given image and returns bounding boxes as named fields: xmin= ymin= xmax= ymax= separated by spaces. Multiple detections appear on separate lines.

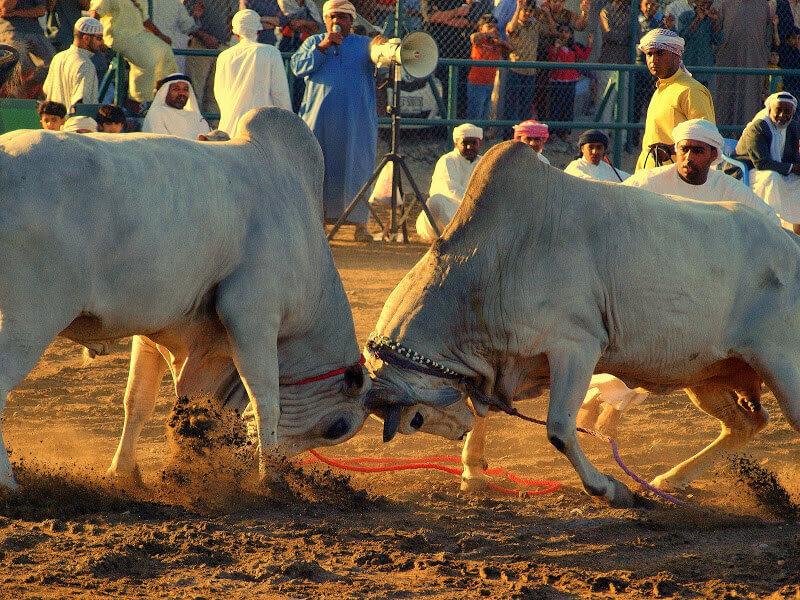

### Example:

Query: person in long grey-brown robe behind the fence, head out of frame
xmin=716 ymin=0 xmax=772 ymax=125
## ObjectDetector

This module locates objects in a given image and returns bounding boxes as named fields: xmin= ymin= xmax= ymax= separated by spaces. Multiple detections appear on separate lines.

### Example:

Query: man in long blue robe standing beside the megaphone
xmin=291 ymin=0 xmax=386 ymax=242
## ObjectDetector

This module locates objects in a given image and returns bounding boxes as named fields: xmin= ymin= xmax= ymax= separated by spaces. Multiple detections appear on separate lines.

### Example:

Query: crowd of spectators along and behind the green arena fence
xmin=0 ymin=0 xmax=800 ymax=241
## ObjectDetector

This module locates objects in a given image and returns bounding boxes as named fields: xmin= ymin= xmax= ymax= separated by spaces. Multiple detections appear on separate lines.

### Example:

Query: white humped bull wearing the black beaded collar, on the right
xmin=368 ymin=142 xmax=800 ymax=506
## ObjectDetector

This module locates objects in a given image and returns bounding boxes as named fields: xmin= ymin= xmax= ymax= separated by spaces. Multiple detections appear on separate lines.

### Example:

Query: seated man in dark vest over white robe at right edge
xmin=734 ymin=92 xmax=800 ymax=234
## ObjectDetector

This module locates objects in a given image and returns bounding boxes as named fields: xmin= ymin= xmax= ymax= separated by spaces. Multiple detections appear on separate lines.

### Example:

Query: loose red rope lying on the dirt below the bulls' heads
xmin=300 ymin=450 xmax=561 ymax=496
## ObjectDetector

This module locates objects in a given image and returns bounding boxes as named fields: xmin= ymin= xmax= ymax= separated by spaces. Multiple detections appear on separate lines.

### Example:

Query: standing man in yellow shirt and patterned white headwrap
xmin=636 ymin=29 xmax=716 ymax=171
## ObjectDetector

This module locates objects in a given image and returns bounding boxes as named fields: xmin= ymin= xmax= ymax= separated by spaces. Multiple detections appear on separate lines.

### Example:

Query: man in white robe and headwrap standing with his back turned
xmin=214 ymin=9 xmax=292 ymax=136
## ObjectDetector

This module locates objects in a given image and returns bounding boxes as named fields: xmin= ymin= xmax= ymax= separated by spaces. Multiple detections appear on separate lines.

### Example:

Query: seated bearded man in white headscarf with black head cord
xmin=142 ymin=73 xmax=211 ymax=140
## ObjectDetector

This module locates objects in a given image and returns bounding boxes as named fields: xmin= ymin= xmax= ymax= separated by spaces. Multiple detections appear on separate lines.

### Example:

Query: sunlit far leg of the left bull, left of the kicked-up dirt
xmin=108 ymin=335 xmax=167 ymax=485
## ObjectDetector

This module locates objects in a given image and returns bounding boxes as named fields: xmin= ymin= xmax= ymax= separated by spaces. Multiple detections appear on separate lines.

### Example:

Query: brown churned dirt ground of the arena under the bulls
xmin=0 ymin=228 xmax=800 ymax=600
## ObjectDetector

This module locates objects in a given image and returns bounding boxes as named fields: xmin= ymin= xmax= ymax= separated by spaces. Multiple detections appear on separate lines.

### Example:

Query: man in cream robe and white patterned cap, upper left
xmin=43 ymin=17 xmax=103 ymax=109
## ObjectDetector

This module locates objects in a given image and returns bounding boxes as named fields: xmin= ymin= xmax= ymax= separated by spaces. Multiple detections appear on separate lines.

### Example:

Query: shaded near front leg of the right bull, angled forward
xmin=547 ymin=346 xmax=635 ymax=507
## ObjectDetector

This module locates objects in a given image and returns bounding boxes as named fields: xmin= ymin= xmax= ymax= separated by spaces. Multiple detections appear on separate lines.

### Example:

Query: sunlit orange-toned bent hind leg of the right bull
xmin=652 ymin=382 xmax=769 ymax=490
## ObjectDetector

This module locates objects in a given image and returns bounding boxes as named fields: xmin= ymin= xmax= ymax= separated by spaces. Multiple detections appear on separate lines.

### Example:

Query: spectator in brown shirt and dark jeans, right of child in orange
xmin=502 ymin=0 xmax=550 ymax=121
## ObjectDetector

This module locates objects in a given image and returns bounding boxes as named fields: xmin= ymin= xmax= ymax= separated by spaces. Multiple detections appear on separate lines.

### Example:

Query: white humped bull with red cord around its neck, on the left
xmin=0 ymin=109 xmax=368 ymax=487
